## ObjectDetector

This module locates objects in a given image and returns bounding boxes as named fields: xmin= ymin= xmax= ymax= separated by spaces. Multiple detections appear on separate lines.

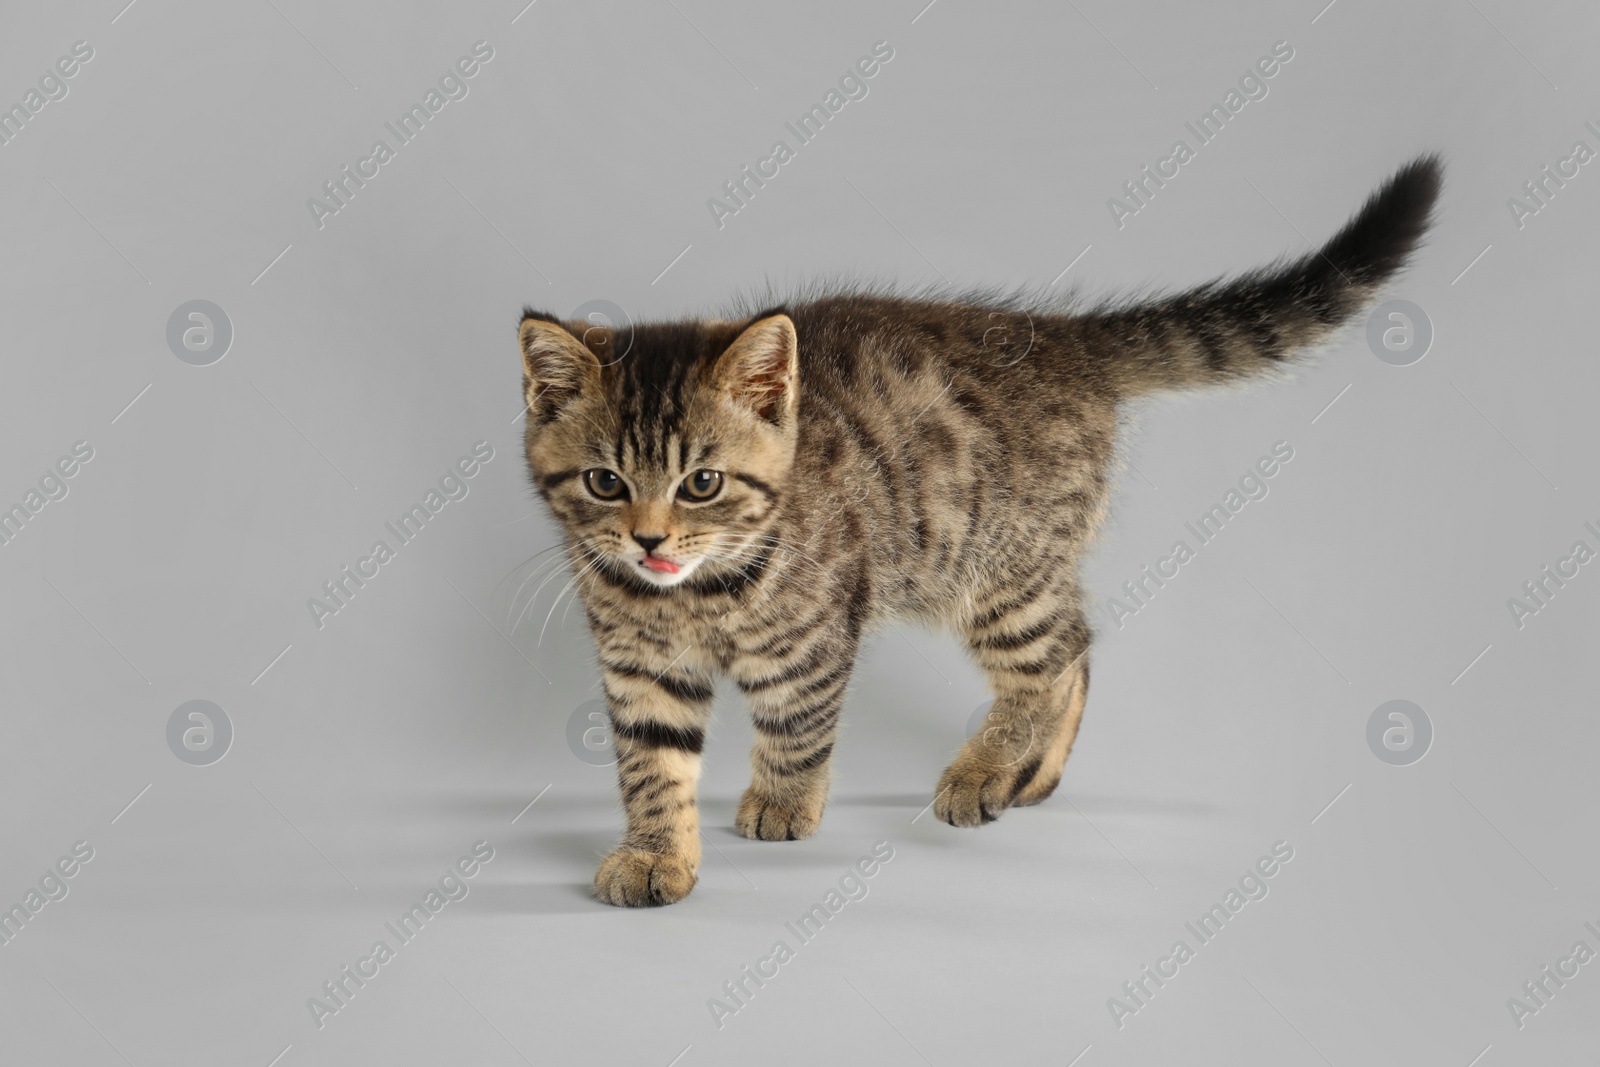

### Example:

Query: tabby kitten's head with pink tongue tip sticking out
xmin=520 ymin=310 xmax=800 ymax=592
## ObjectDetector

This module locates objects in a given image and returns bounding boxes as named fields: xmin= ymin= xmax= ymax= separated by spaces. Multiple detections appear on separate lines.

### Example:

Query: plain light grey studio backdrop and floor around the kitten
xmin=0 ymin=0 xmax=1600 ymax=1067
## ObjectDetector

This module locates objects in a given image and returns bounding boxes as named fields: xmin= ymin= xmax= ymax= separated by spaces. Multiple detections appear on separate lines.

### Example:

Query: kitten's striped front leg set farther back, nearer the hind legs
xmin=730 ymin=627 xmax=859 ymax=841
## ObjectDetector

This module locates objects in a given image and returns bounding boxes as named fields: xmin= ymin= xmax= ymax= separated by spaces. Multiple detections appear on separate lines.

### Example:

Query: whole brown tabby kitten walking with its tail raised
xmin=520 ymin=157 xmax=1442 ymax=905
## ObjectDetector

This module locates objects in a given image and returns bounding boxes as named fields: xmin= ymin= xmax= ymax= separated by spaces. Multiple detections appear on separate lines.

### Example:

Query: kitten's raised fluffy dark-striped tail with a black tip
xmin=1080 ymin=155 xmax=1443 ymax=395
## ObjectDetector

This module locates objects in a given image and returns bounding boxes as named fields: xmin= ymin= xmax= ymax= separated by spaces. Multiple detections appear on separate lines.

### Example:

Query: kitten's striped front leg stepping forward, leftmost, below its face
xmin=595 ymin=649 xmax=712 ymax=907
